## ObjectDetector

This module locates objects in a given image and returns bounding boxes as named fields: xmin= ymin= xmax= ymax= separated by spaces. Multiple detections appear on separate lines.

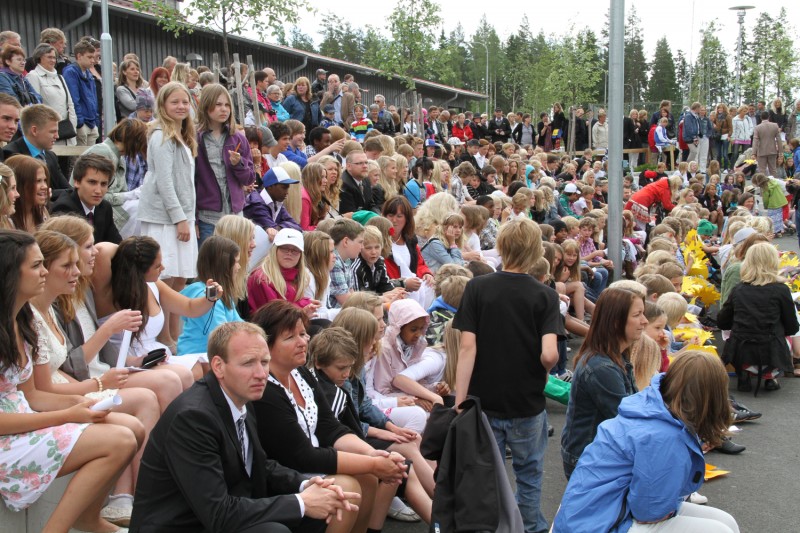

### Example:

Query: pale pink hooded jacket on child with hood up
xmin=373 ymin=298 xmax=430 ymax=395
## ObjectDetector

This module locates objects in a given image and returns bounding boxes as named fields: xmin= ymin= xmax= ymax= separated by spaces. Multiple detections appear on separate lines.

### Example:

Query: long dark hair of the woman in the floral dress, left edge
xmin=0 ymin=229 xmax=39 ymax=373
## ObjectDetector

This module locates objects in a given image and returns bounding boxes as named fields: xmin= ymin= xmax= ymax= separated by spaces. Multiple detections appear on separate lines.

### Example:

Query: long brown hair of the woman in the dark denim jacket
xmin=574 ymin=288 xmax=644 ymax=368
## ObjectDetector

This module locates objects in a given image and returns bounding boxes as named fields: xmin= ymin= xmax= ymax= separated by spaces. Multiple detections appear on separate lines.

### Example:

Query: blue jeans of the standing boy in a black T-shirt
xmin=488 ymin=411 xmax=550 ymax=533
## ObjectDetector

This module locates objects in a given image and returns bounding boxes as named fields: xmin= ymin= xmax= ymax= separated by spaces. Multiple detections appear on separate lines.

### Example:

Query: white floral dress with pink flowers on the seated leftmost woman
xmin=0 ymin=350 xmax=89 ymax=511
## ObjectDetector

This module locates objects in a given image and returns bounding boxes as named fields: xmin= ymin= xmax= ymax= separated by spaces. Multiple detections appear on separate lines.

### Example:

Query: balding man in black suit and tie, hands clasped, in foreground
xmin=130 ymin=322 xmax=358 ymax=533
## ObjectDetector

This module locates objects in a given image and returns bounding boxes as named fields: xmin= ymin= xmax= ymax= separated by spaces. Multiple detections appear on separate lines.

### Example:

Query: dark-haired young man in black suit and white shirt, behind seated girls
xmin=51 ymin=153 xmax=122 ymax=244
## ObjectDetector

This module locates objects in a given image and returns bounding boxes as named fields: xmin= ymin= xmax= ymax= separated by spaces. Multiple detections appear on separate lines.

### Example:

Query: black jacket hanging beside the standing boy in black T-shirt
xmin=420 ymin=398 xmax=524 ymax=533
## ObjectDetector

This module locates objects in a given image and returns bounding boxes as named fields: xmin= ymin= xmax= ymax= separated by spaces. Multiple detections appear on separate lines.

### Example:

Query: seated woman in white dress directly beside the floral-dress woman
xmin=31 ymin=230 xmax=160 ymax=525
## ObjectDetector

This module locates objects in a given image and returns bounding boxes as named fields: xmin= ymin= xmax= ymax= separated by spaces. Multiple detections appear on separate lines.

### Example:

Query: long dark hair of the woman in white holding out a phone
xmin=111 ymin=237 xmax=161 ymax=339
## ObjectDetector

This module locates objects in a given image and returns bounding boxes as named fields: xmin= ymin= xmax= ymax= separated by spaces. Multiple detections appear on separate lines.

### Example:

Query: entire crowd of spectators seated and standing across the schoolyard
xmin=0 ymin=23 xmax=800 ymax=533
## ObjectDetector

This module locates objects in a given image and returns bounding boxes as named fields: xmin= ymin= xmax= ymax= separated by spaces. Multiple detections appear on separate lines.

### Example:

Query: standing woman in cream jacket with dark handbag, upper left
xmin=25 ymin=44 xmax=78 ymax=146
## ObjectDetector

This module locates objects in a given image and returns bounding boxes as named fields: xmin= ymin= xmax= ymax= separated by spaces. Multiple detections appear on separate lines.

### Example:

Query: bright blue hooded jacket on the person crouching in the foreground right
xmin=553 ymin=374 xmax=705 ymax=533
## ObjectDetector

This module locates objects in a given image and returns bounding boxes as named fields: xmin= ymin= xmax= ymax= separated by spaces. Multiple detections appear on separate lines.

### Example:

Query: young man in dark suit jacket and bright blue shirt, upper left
xmin=3 ymin=104 xmax=70 ymax=191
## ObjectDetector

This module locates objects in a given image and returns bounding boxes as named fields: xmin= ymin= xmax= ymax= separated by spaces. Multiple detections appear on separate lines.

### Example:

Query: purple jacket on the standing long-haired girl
xmin=194 ymin=131 xmax=256 ymax=213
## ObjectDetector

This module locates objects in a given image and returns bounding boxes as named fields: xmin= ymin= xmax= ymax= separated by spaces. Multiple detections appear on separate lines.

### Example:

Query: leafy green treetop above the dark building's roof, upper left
xmin=133 ymin=0 xmax=312 ymax=62
